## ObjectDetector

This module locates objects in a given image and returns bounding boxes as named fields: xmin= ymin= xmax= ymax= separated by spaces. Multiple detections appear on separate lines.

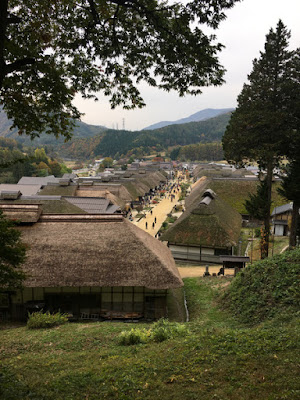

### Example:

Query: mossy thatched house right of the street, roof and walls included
xmin=160 ymin=187 xmax=242 ymax=262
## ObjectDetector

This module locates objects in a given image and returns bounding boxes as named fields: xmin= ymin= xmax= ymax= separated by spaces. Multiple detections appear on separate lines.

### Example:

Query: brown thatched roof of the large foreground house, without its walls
xmin=18 ymin=214 xmax=183 ymax=289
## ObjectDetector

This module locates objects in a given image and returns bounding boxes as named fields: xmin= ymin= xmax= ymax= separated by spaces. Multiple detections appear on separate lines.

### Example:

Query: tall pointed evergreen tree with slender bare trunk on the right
xmin=223 ymin=21 xmax=299 ymax=258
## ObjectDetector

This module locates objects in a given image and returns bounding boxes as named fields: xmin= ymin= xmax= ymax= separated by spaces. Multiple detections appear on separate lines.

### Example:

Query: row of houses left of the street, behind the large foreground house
xmin=0 ymin=171 xmax=167 ymax=214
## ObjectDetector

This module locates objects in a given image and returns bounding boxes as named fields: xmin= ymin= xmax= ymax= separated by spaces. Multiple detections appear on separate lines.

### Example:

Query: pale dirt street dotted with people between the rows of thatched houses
xmin=133 ymin=179 xmax=181 ymax=236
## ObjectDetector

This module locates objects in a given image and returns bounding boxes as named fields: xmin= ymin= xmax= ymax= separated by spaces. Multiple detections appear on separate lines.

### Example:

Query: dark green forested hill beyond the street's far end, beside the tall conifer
xmin=90 ymin=113 xmax=231 ymax=157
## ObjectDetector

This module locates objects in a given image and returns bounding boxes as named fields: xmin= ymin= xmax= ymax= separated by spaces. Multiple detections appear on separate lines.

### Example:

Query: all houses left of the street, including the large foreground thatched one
xmin=0 ymin=171 xmax=183 ymax=320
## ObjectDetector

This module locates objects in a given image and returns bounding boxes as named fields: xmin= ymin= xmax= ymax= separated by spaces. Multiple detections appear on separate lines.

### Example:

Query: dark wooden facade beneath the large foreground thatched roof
xmin=5 ymin=286 xmax=168 ymax=320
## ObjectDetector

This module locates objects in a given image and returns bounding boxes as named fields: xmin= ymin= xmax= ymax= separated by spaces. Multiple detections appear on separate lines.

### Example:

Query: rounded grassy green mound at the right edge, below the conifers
xmin=223 ymin=249 xmax=300 ymax=324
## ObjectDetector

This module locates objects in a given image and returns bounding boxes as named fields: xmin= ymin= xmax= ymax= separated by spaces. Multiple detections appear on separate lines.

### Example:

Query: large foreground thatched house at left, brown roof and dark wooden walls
xmin=10 ymin=214 xmax=183 ymax=319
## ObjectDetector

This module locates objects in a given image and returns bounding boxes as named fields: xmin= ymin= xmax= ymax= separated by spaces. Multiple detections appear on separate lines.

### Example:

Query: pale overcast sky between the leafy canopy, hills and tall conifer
xmin=75 ymin=0 xmax=300 ymax=130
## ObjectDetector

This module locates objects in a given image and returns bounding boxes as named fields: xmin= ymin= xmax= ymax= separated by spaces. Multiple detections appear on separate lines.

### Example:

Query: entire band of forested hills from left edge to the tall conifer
xmin=0 ymin=112 xmax=231 ymax=160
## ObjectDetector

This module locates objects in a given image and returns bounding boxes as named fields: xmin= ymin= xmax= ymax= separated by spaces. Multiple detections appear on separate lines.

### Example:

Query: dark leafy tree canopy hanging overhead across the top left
xmin=0 ymin=0 xmax=240 ymax=138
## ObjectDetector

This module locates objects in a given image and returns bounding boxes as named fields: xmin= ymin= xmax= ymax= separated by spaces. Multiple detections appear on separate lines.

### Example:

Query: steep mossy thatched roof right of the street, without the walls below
xmin=161 ymin=189 xmax=242 ymax=247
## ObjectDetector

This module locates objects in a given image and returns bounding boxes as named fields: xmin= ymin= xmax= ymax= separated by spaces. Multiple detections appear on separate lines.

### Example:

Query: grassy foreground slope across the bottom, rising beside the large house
xmin=0 ymin=278 xmax=300 ymax=400
